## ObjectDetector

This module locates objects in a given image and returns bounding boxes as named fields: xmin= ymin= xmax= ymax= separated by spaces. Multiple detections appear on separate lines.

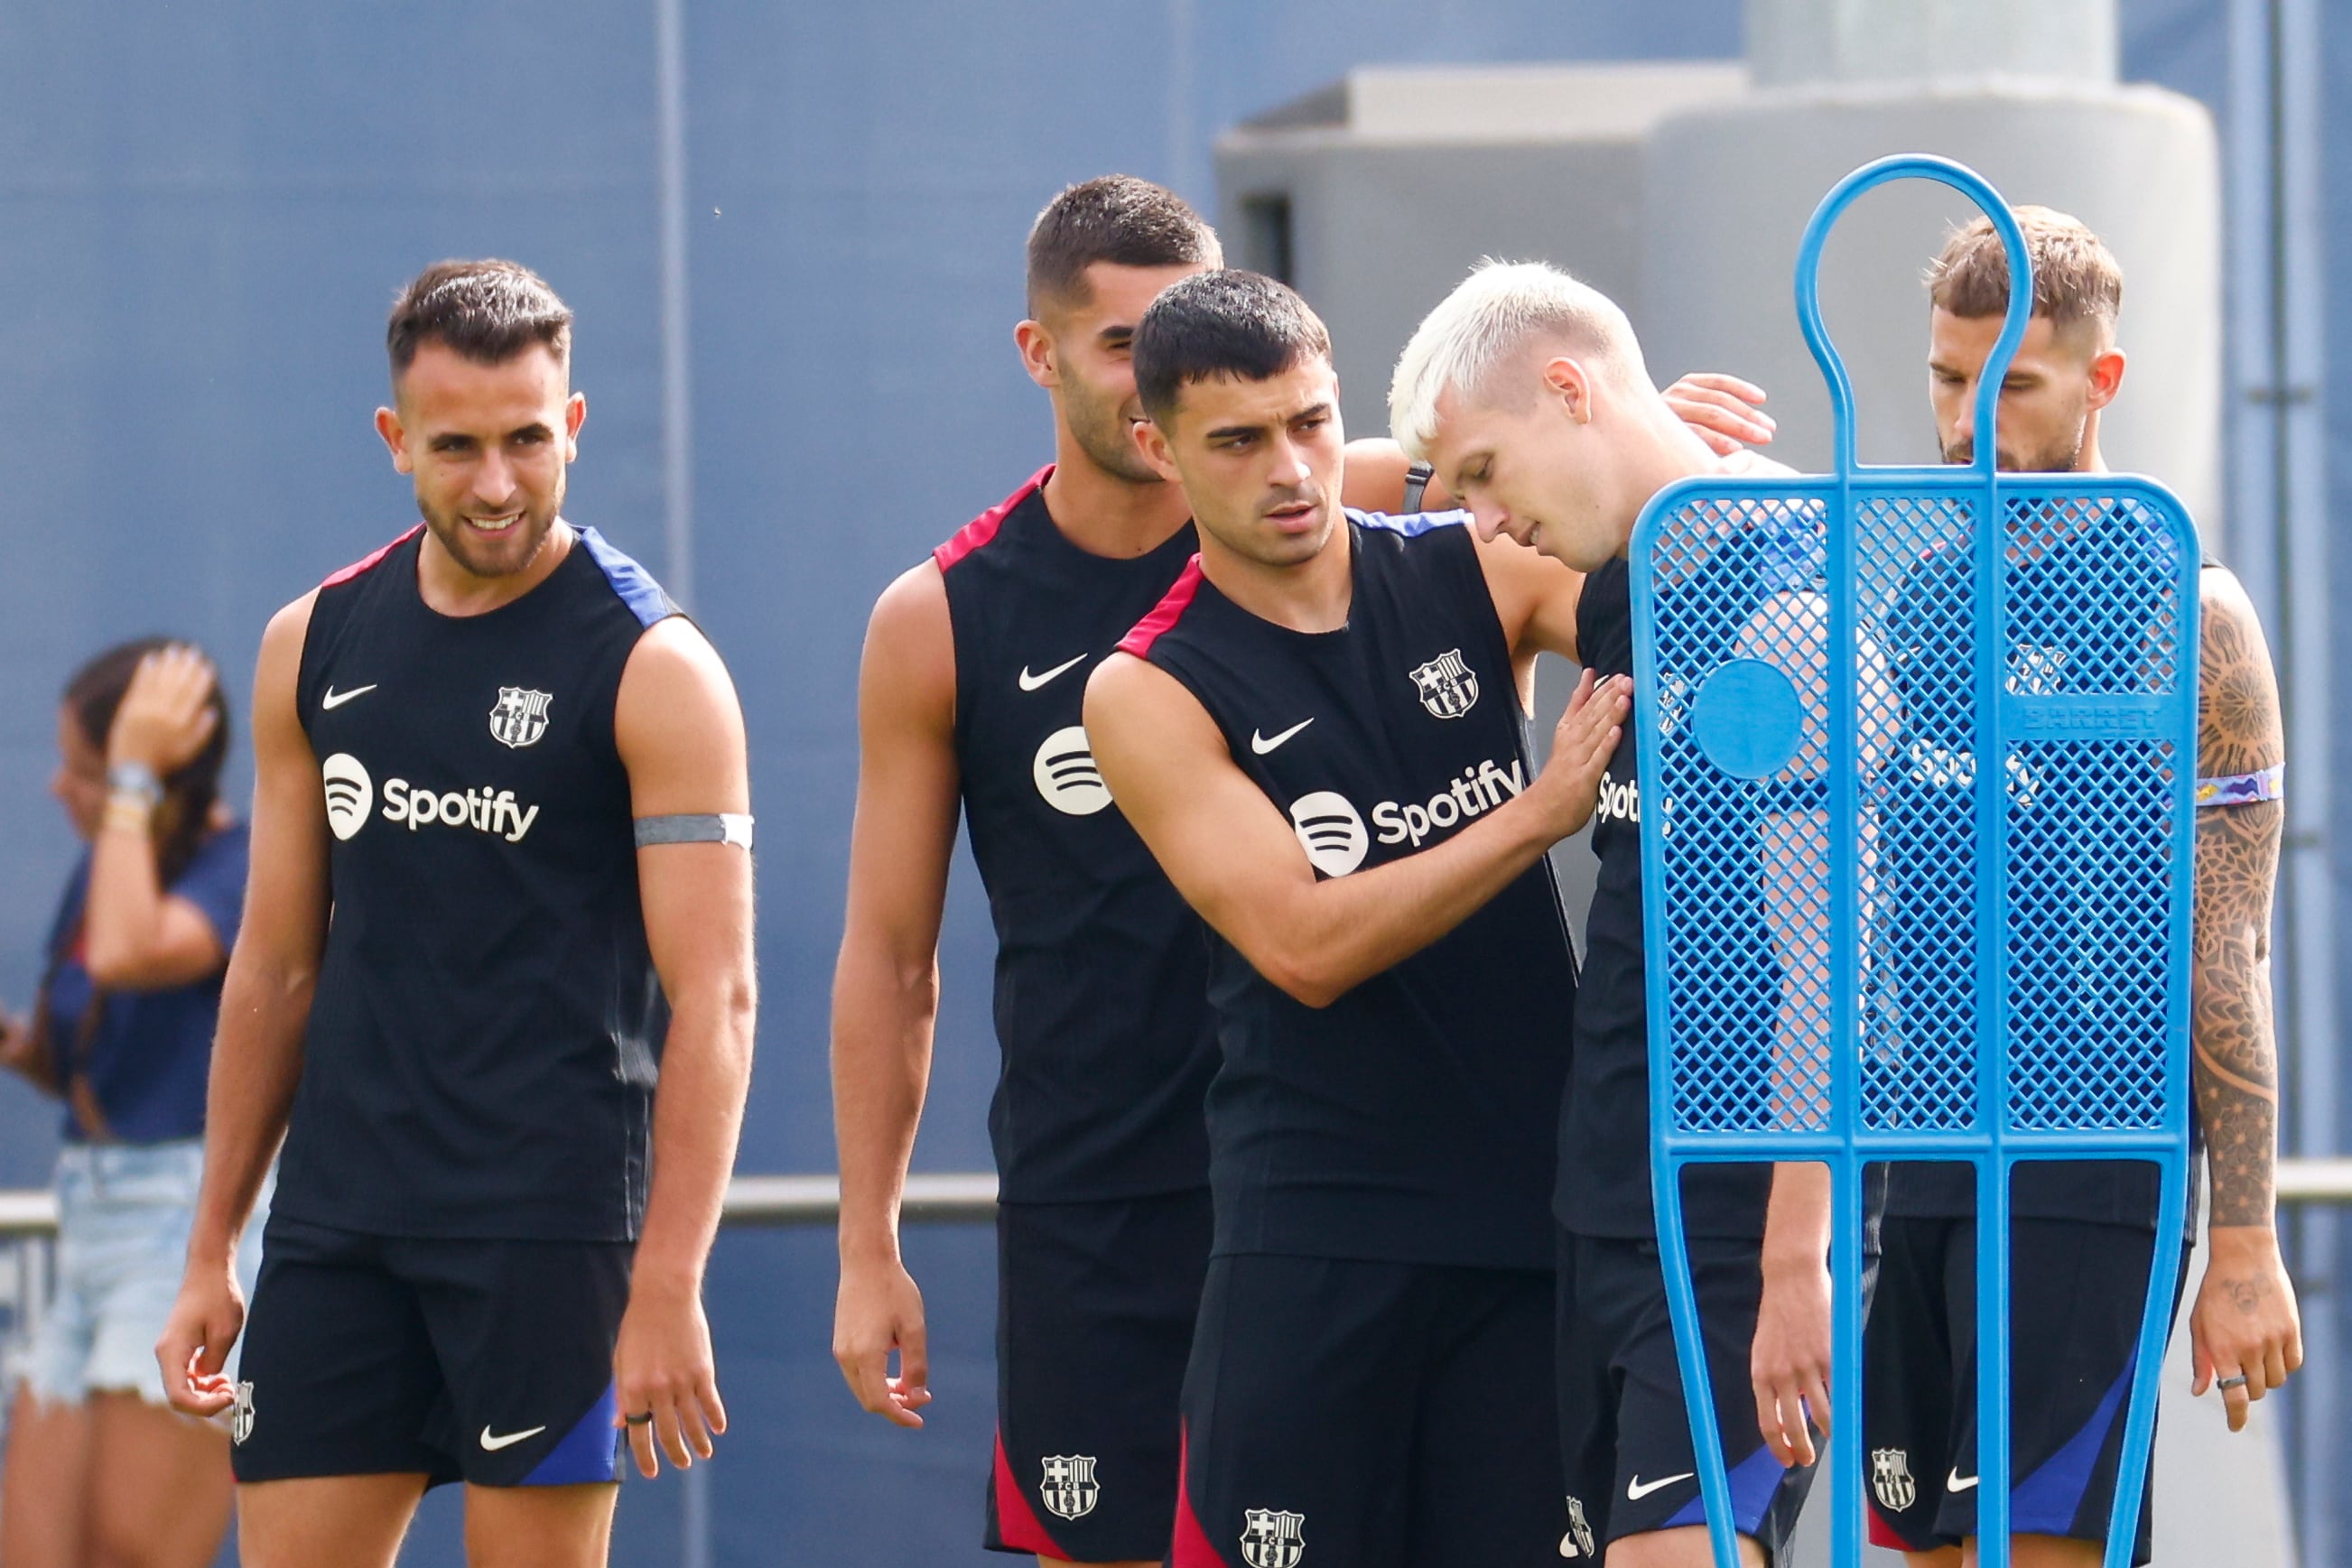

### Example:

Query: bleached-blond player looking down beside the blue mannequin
xmin=1390 ymin=264 xmax=1830 ymax=1568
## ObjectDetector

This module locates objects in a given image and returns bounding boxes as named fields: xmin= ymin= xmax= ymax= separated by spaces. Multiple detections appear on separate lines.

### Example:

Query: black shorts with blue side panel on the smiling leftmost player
xmin=230 ymin=1218 xmax=635 ymax=1486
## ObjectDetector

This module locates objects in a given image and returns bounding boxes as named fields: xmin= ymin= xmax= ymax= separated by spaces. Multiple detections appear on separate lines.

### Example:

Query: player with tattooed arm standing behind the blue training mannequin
xmin=1863 ymin=207 xmax=2302 ymax=1568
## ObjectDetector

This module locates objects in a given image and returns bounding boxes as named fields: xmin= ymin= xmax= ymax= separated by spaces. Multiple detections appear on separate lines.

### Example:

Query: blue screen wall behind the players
xmin=0 ymin=0 xmax=2352 ymax=1565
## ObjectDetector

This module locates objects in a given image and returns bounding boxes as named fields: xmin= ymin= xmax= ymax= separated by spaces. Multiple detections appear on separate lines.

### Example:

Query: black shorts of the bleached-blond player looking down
xmin=1555 ymin=1232 xmax=1816 ymax=1563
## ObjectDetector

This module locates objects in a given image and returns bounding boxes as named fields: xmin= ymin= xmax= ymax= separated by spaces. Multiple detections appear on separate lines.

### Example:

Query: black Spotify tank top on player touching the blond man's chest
xmin=1120 ymin=513 xmax=1576 ymax=1269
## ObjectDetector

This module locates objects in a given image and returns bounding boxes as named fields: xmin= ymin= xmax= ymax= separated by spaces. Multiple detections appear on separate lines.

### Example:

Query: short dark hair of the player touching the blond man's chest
xmin=1134 ymin=268 xmax=1331 ymax=419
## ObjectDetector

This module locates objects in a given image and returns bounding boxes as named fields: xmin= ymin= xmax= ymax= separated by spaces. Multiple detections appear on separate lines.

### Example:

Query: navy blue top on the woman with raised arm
xmin=47 ymin=822 xmax=249 ymax=1143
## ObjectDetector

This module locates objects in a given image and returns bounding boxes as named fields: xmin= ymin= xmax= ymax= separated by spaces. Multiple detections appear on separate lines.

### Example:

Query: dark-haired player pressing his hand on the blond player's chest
xmin=1087 ymin=273 xmax=1621 ymax=1568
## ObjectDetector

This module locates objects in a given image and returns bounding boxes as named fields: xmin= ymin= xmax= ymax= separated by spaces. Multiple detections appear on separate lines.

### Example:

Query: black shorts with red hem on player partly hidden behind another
xmin=985 ymin=1187 xmax=1212 ymax=1563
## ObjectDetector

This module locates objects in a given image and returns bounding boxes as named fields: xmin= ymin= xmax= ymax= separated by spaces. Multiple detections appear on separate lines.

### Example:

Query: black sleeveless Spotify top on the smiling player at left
xmin=275 ymin=529 xmax=677 ymax=1241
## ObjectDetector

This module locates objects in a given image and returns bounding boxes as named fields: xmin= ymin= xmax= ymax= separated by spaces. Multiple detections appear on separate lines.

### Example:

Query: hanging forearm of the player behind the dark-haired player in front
xmin=832 ymin=950 xmax=938 ymax=1256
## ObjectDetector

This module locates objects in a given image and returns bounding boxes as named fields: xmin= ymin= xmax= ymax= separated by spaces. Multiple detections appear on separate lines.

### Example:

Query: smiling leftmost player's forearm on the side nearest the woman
xmin=188 ymin=961 xmax=318 ymax=1262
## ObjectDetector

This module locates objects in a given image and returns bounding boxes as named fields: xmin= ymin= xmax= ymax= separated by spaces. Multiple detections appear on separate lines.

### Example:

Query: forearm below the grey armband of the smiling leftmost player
xmin=635 ymin=980 xmax=753 ymax=1288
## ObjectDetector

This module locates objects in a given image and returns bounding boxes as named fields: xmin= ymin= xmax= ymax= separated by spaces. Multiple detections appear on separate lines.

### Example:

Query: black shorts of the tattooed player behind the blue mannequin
xmin=1863 ymin=1215 xmax=2188 ymax=1563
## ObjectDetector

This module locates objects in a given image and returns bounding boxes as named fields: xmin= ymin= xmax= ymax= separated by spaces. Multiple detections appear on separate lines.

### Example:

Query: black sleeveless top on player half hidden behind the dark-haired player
xmin=932 ymin=468 xmax=1216 ymax=1203
